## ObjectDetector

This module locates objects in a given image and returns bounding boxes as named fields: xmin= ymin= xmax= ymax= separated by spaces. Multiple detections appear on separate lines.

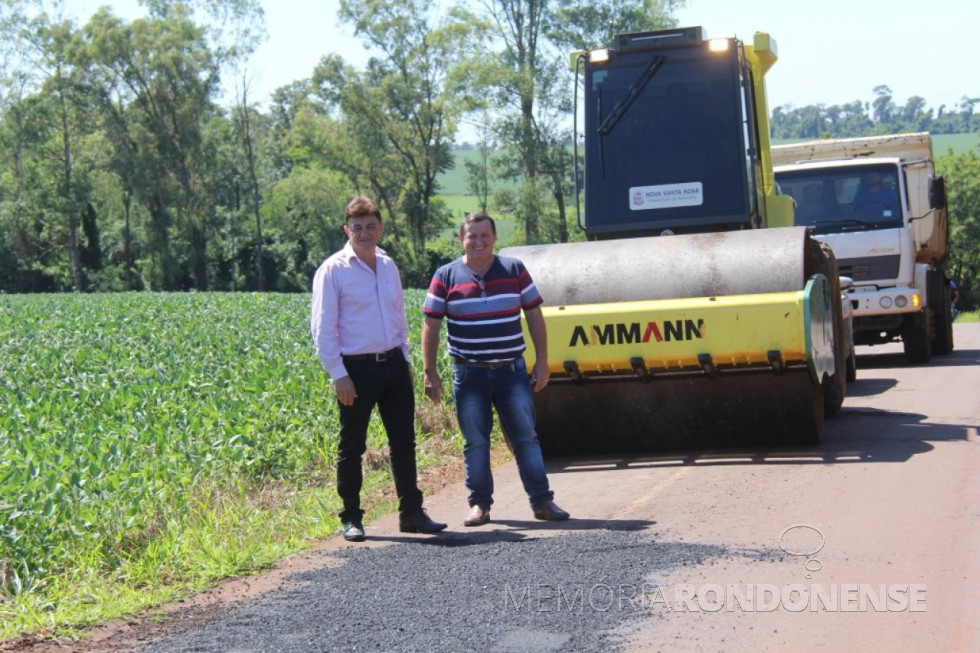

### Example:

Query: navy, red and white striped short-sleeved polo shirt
xmin=422 ymin=255 xmax=544 ymax=363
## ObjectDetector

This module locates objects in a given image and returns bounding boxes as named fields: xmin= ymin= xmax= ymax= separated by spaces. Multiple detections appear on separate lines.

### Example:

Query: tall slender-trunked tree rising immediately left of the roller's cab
xmin=460 ymin=0 xmax=683 ymax=243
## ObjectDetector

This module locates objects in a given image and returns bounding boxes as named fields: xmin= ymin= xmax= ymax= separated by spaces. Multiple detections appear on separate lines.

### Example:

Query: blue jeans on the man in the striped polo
xmin=453 ymin=358 xmax=554 ymax=508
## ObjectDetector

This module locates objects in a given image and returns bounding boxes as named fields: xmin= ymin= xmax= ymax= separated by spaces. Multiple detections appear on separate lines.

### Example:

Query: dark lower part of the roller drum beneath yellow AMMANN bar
xmin=535 ymin=373 xmax=823 ymax=456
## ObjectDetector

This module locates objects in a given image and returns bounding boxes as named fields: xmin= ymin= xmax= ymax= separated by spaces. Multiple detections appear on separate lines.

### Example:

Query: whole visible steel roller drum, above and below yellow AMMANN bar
xmin=501 ymin=227 xmax=824 ymax=455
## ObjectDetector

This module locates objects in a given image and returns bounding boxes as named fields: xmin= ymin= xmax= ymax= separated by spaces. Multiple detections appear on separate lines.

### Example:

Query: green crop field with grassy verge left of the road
xmin=0 ymin=290 xmax=455 ymax=639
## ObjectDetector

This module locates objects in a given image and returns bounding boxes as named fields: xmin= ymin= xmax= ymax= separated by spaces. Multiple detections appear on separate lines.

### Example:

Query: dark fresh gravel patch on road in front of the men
xmin=142 ymin=530 xmax=729 ymax=653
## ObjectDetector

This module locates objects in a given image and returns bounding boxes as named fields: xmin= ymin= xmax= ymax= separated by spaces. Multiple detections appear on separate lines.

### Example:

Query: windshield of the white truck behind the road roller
xmin=776 ymin=164 xmax=903 ymax=234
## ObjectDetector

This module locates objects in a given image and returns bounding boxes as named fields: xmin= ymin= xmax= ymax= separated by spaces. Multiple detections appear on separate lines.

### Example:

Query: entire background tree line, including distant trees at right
xmin=0 ymin=0 xmax=980 ymax=310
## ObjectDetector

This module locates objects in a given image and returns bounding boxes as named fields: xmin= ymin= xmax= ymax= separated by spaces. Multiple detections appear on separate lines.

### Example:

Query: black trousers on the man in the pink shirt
xmin=337 ymin=355 xmax=422 ymax=522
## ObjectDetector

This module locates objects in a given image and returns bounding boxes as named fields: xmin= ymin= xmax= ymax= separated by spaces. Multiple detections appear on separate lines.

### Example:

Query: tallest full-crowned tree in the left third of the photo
xmin=77 ymin=3 xmax=218 ymax=290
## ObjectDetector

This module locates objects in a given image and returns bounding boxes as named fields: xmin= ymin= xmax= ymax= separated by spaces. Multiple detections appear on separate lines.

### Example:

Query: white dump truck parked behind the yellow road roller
xmin=773 ymin=132 xmax=953 ymax=363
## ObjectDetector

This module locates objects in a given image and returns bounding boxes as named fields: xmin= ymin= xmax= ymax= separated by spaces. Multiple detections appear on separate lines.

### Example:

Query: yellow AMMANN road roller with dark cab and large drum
xmin=501 ymin=27 xmax=846 ymax=455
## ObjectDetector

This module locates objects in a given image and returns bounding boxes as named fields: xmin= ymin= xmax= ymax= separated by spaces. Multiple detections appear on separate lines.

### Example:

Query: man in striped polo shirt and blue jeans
xmin=422 ymin=213 xmax=568 ymax=526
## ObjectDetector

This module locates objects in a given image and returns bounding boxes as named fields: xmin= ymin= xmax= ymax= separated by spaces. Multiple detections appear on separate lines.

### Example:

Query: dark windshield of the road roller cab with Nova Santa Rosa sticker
xmin=584 ymin=40 xmax=752 ymax=232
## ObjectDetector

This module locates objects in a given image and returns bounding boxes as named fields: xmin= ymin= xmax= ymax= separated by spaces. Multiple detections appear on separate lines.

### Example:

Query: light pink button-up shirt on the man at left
xmin=310 ymin=242 xmax=408 ymax=381
